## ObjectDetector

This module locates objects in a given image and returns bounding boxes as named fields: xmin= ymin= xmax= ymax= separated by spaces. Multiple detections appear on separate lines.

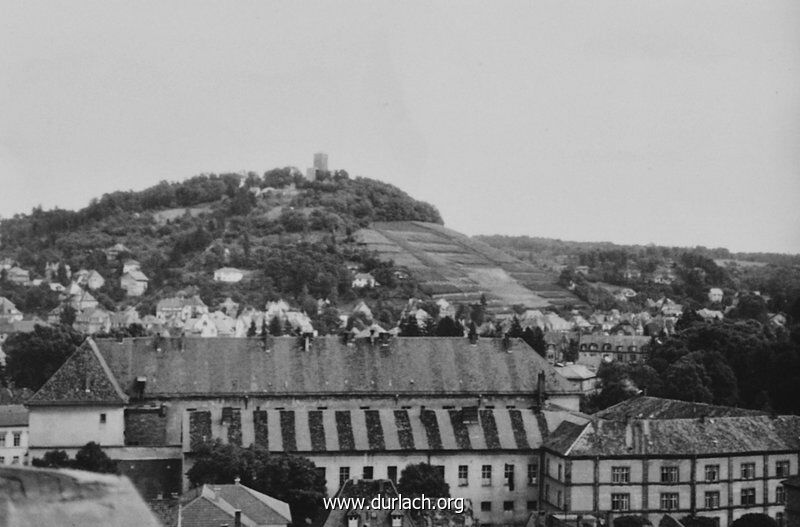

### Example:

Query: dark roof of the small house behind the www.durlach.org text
xmin=315 ymin=479 xmax=416 ymax=527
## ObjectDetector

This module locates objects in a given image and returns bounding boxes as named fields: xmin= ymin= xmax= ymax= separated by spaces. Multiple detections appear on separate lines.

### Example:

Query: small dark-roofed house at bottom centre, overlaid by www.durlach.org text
xmin=316 ymin=478 xmax=419 ymax=527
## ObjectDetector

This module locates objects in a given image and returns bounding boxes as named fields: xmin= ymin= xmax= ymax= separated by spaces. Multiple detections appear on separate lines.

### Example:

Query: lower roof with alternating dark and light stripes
xmin=183 ymin=407 xmax=587 ymax=453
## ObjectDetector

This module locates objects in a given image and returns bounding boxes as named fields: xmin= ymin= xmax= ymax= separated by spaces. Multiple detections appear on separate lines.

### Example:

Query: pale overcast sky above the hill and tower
xmin=0 ymin=0 xmax=800 ymax=253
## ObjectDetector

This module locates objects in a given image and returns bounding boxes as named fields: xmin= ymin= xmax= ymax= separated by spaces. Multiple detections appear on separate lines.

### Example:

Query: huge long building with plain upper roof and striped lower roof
xmin=28 ymin=337 xmax=587 ymax=523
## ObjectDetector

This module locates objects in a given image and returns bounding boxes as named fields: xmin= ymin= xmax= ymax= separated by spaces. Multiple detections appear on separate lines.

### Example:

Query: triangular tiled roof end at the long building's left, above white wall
xmin=27 ymin=339 xmax=128 ymax=406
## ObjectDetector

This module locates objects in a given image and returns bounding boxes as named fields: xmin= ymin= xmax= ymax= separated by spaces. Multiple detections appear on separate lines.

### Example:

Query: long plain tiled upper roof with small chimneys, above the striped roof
xmin=92 ymin=336 xmax=573 ymax=397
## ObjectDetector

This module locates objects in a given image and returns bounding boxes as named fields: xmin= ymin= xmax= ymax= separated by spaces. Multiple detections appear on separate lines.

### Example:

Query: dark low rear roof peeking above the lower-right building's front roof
xmin=595 ymin=396 xmax=766 ymax=420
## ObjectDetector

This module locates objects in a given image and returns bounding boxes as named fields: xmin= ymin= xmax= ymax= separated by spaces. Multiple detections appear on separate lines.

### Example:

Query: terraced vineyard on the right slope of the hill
xmin=356 ymin=221 xmax=580 ymax=312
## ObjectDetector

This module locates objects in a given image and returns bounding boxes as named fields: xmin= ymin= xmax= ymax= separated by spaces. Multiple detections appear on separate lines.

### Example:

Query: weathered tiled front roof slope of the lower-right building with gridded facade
xmin=545 ymin=415 xmax=800 ymax=456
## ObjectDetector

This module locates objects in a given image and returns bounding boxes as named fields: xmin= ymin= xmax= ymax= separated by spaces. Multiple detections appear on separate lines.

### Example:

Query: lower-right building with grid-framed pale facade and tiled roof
xmin=539 ymin=397 xmax=800 ymax=525
